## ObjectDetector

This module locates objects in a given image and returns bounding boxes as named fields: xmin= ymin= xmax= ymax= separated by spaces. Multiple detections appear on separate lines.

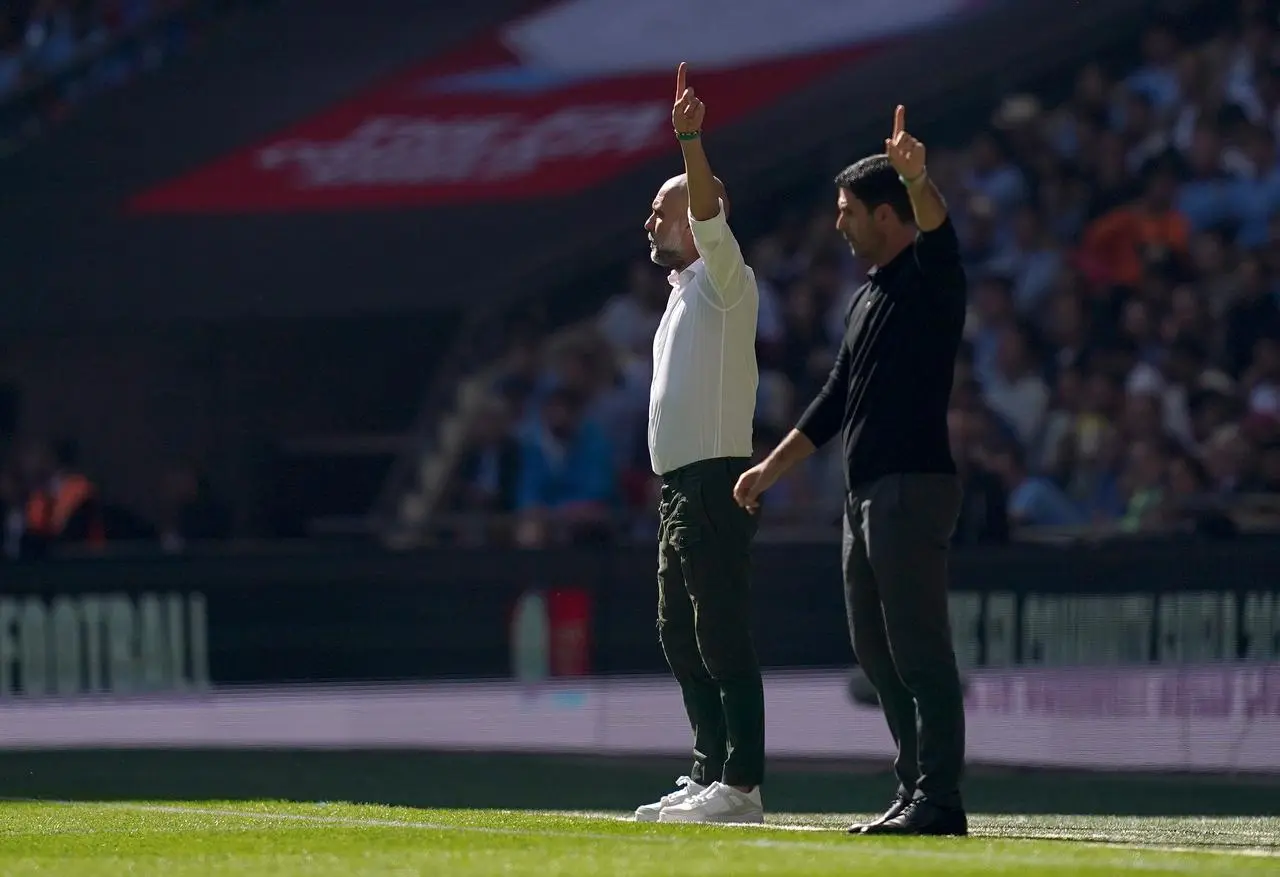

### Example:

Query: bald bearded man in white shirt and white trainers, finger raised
xmin=636 ymin=64 xmax=764 ymax=822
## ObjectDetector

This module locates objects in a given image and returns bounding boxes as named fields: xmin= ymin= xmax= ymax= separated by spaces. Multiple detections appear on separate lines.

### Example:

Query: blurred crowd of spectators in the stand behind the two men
xmin=449 ymin=1 xmax=1280 ymax=545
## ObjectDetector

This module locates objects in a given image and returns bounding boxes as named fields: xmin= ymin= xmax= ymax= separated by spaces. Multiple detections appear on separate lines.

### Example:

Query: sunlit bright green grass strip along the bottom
xmin=0 ymin=800 xmax=1280 ymax=877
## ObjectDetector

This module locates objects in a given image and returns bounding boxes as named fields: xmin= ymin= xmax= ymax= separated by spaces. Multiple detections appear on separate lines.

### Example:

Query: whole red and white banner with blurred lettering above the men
xmin=129 ymin=0 xmax=986 ymax=213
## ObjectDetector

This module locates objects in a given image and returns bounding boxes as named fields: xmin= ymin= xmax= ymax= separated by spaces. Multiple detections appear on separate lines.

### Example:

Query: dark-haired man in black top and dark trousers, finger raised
xmin=733 ymin=106 xmax=968 ymax=835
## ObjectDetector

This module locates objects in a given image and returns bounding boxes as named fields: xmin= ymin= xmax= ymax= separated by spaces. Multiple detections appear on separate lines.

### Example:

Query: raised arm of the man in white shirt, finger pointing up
xmin=671 ymin=63 xmax=750 ymax=307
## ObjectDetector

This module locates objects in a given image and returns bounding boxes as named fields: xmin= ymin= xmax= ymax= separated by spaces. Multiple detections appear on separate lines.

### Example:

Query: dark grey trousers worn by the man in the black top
xmin=844 ymin=474 xmax=965 ymax=807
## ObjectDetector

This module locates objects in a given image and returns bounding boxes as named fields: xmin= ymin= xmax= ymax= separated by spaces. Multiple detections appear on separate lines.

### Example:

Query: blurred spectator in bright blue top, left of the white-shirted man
xmin=516 ymin=387 xmax=616 ymax=547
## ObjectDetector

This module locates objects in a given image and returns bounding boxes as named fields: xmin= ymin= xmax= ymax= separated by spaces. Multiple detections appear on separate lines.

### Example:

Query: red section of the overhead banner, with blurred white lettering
xmin=129 ymin=38 xmax=872 ymax=213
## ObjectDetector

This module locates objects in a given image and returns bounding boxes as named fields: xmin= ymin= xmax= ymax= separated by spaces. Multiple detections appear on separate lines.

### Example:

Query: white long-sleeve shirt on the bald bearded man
xmin=649 ymin=201 xmax=760 ymax=475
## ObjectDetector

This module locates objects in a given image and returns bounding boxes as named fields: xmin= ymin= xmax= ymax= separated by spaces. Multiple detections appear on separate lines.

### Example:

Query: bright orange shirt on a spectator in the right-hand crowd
xmin=1079 ymin=205 xmax=1190 ymax=287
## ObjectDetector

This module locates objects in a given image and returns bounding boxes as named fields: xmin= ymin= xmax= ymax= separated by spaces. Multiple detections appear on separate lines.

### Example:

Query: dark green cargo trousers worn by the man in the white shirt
xmin=658 ymin=457 xmax=764 ymax=786
